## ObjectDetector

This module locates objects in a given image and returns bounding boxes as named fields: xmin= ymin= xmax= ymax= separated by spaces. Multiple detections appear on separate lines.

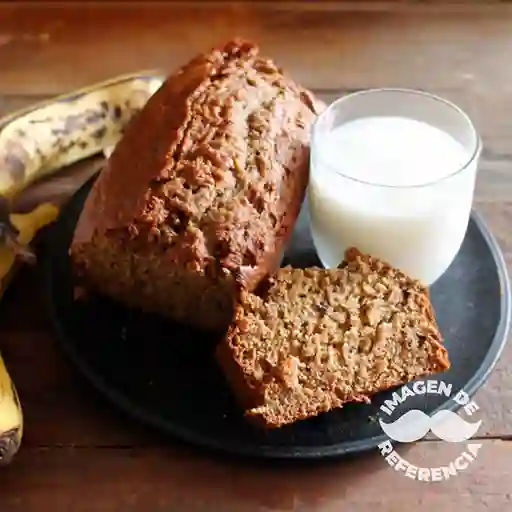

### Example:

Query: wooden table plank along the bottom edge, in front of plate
xmin=0 ymin=441 xmax=512 ymax=512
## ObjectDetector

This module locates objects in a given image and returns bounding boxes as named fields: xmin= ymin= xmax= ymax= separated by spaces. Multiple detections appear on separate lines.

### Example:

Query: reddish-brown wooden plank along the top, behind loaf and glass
xmin=0 ymin=2 xmax=512 ymax=94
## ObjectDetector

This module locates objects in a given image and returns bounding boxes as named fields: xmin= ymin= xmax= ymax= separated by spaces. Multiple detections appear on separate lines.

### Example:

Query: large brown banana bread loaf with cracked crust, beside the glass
xmin=70 ymin=40 xmax=316 ymax=330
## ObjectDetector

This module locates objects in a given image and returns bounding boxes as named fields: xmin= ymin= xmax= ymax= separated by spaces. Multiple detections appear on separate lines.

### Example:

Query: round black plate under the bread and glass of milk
xmin=46 ymin=180 xmax=510 ymax=459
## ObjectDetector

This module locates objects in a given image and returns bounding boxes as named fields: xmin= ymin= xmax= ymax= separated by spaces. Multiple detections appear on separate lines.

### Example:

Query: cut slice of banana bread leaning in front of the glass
xmin=217 ymin=248 xmax=450 ymax=427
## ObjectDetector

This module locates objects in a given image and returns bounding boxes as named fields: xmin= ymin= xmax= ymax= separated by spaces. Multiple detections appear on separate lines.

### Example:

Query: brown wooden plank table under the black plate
xmin=0 ymin=0 xmax=512 ymax=512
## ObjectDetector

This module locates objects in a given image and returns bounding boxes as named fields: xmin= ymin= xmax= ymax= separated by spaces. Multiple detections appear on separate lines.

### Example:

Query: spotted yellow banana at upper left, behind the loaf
xmin=0 ymin=72 xmax=163 ymax=199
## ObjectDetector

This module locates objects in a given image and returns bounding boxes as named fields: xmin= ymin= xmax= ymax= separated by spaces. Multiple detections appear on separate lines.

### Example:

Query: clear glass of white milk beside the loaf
xmin=308 ymin=89 xmax=481 ymax=285
